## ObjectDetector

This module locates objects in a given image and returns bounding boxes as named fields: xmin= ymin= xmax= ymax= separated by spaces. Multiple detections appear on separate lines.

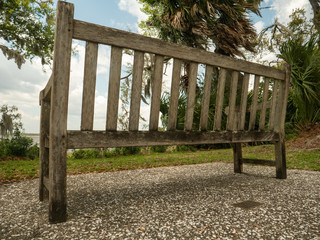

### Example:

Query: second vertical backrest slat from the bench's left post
xmin=106 ymin=46 xmax=122 ymax=131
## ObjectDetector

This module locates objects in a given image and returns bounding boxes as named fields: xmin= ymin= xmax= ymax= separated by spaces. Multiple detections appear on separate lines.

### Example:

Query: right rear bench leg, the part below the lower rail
xmin=275 ymin=140 xmax=287 ymax=179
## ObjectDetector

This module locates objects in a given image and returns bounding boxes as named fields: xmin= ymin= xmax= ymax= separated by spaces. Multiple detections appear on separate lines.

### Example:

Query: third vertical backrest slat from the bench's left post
xmin=129 ymin=51 xmax=144 ymax=131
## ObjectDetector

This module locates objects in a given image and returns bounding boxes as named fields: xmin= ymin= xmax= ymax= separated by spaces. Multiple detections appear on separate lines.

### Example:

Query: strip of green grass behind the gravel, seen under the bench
xmin=0 ymin=145 xmax=320 ymax=182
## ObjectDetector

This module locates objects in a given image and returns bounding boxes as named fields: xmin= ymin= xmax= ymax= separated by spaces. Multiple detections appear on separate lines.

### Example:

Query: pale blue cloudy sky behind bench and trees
xmin=0 ymin=0 xmax=311 ymax=133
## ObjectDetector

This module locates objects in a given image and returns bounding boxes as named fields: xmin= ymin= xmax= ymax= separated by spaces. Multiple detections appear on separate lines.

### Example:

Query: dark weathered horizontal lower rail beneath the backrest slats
xmin=68 ymin=130 xmax=279 ymax=149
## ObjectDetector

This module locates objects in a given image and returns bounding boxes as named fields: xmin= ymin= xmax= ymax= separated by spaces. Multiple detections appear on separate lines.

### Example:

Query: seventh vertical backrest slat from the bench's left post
xmin=200 ymin=65 xmax=213 ymax=131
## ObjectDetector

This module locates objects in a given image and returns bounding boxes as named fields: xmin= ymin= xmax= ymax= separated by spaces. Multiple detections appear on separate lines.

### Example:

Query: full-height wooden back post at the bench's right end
xmin=274 ymin=64 xmax=291 ymax=179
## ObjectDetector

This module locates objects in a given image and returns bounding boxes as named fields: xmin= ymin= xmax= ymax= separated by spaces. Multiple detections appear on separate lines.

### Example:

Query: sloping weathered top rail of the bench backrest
xmin=73 ymin=20 xmax=285 ymax=80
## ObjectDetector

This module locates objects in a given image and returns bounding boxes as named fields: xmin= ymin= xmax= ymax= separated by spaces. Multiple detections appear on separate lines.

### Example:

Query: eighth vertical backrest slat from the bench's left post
xmin=214 ymin=68 xmax=227 ymax=131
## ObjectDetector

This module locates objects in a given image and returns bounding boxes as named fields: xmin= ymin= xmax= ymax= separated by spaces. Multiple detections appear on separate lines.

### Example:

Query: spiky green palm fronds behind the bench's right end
xmin=279 ymin=36 xmax=320 ymax=124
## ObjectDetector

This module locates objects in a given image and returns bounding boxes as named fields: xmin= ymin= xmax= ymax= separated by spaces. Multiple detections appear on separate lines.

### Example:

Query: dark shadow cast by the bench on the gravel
xmin=68 ymin=173 xmax=272 ymax=219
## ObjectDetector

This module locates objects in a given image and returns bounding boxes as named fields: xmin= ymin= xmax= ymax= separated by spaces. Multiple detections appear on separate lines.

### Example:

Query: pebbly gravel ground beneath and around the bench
xmin=0 ymin=163 xmax=320 ymax=240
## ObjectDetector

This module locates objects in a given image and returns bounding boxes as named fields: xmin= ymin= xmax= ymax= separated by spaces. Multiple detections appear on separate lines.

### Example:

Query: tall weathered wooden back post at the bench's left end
xmin=49 ymin=1 xmax=73 ymax=223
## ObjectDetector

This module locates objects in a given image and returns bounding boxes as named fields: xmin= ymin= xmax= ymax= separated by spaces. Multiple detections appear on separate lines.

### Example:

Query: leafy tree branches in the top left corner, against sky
xmin=0 ymin=0 xmax=55 ymax=68
